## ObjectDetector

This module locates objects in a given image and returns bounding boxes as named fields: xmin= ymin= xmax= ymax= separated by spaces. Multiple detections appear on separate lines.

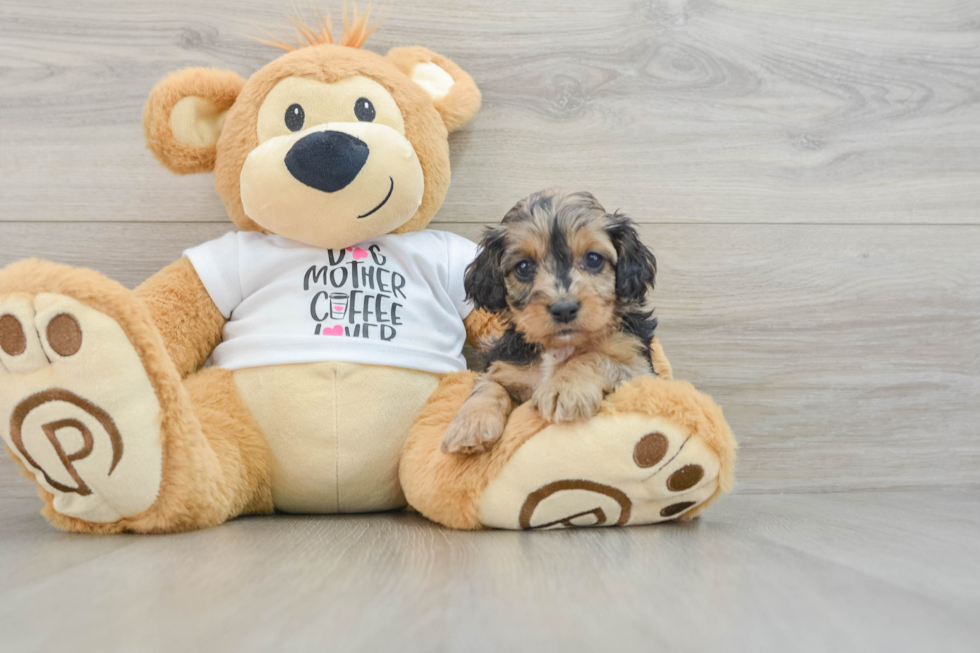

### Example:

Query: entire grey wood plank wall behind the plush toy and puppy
xmin=0 ymin=0 xmax=980 ymax=492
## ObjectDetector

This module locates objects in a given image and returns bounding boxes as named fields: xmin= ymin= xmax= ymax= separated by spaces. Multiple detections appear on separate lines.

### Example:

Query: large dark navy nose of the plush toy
xmin=286 ymin=131 xmax=369 ymax=193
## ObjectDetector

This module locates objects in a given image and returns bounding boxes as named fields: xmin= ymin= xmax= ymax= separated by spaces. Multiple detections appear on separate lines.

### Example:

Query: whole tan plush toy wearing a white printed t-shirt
xmin=0 ymin=8 xmax=734 ymax=533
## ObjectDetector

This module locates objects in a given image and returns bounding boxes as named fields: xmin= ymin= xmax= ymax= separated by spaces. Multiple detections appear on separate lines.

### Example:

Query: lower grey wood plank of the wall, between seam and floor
xmin=0 ymin=223 xmax=980 ymax=492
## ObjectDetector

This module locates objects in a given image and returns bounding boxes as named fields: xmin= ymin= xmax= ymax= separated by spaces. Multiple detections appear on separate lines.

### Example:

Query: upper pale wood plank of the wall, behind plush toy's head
xmin=0 ymin=0 xmax=980 ymax=224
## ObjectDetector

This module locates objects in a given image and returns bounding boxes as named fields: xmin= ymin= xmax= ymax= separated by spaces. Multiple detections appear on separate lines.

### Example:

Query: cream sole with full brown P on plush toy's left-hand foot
xmin=0 ymin=294 xmax=163 ymax=523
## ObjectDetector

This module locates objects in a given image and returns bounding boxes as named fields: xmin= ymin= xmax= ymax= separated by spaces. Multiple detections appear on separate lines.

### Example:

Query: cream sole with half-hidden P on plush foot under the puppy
xmin=480 ymin=414 xmax=720 ymax=529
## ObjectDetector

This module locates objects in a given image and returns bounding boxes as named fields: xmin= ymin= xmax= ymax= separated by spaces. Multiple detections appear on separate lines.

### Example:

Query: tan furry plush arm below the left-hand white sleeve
xmin=135 ymin=258 xmax=225 ymax=377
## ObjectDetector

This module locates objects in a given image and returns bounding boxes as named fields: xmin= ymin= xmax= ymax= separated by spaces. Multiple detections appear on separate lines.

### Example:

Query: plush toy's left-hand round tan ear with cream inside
xmin=143 ymin=68 xmax=245 ymax=175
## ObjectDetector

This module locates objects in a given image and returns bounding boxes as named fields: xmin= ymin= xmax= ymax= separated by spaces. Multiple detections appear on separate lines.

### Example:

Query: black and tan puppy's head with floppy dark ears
xmin=465 ymin=189 xmax=657 ymax=349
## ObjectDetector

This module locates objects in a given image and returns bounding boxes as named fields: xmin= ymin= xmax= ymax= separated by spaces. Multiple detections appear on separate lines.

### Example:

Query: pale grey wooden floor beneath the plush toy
xmin=0 ymin=490 xmax=980 ymax=653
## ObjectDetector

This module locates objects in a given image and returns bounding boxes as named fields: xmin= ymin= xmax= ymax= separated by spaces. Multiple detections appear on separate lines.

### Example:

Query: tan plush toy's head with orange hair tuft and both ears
xmin=143 ymin=13 xmax=480 ymax=249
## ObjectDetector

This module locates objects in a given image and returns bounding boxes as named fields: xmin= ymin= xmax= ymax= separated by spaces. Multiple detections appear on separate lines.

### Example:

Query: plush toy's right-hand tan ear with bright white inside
xmin=388 ymin=47 xmax=480 ymax=131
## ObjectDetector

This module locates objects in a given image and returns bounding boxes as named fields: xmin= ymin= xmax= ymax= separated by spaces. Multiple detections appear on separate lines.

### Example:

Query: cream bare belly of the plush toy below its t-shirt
xmin=234 ymin=363 xmax=439 ymax=513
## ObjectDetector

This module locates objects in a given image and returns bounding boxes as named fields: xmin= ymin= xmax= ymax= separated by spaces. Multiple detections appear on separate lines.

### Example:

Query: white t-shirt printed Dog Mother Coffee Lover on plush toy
xmin=184 ymin=230 xmax=476 ymax=374
